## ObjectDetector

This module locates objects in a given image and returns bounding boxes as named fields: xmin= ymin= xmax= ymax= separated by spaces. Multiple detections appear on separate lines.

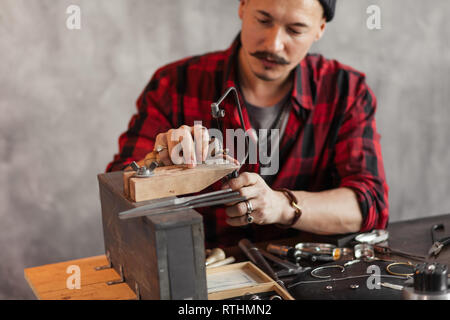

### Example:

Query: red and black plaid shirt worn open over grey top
xmin=106 ymin=36 xmax=389 ymax=247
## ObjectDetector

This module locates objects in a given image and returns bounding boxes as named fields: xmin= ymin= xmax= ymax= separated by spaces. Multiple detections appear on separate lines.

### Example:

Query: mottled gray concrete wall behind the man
xmin=0 ymin=0 xmax=450 ymax=299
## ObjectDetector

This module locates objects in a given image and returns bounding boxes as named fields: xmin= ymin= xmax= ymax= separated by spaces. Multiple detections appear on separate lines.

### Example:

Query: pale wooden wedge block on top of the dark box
xmin=123 ymin=163 xmax=239 ymax=202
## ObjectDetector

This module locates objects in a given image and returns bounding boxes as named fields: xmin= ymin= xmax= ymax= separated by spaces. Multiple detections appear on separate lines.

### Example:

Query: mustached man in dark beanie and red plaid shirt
xmin=107 ymin=0 xmax=388 ymax=246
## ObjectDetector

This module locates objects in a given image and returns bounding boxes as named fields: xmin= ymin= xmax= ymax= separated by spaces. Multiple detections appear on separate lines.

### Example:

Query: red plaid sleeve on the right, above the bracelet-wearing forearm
xmin=334 ymin=77 xmax=389 ymax=231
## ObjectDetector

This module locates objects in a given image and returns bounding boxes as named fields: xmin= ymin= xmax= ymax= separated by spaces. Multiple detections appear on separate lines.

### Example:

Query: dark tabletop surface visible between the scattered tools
xmin=224 ymin=214 xmax=450 ymax=300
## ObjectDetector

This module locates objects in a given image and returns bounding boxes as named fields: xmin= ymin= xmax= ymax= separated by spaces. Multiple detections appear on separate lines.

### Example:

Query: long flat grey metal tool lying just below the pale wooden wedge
xmin=119 ymin=189 xmax=247 ymax=219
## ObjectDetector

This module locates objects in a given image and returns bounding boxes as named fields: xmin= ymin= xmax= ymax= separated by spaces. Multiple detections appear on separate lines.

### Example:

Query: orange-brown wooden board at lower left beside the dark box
xmin=24 ymin=255 xmax=136 ymax=300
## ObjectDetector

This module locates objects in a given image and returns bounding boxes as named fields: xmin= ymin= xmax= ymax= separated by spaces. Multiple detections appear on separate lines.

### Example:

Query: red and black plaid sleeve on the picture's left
xmin=106 ymin=68 xmax=180 ymax=172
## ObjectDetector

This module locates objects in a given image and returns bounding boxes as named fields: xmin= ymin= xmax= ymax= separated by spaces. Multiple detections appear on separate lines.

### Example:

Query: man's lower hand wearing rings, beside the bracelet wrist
xmin=222 ymin=172 xmax=294 ymax=226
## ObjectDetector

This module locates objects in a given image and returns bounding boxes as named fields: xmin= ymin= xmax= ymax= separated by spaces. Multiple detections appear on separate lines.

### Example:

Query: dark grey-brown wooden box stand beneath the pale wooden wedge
xmin=98 ymin=172 xmax=208 ymax=299
